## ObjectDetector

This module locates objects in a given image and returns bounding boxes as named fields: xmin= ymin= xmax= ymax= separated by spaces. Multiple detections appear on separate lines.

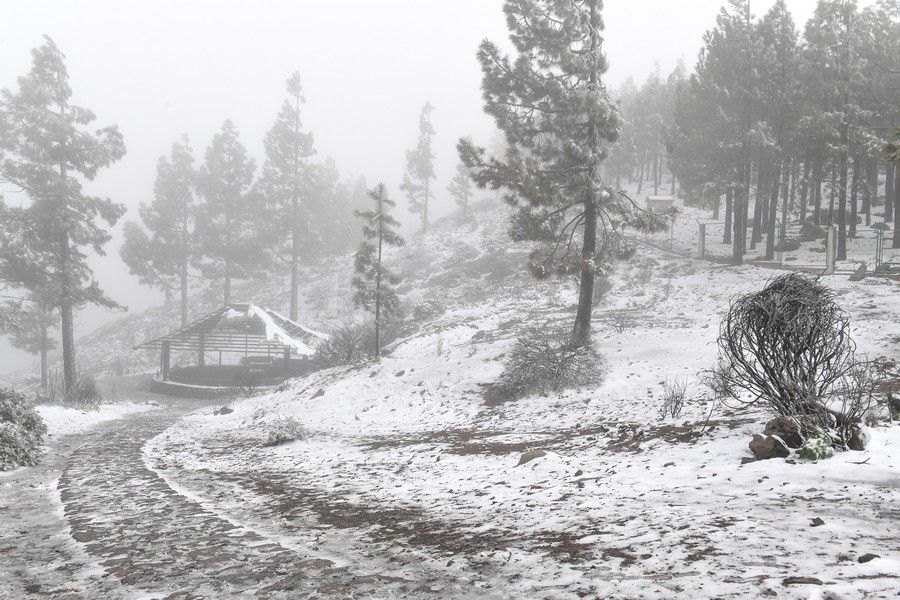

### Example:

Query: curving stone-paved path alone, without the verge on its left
xmin=51 ymin=410 xmax=422 ymax=599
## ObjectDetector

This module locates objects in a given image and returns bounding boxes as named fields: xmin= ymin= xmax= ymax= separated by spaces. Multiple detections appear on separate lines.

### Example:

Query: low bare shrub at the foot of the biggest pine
xmin=497 ymin=329 xmax=602 ymax=398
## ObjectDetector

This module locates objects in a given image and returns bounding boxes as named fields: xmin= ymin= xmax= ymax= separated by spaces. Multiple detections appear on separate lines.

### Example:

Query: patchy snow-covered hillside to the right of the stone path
xmin=146 ymin=204 xmax=900 ymax=598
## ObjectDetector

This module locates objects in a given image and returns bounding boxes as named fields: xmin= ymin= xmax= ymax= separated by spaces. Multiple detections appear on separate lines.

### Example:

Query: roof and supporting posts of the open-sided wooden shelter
xmin=135 ymin=304 xmax=328 ymax=386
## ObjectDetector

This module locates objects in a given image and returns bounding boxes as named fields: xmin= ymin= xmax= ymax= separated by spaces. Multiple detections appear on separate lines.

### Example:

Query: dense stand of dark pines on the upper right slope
xmin=606 ymin=0 xmax=900 ymax=262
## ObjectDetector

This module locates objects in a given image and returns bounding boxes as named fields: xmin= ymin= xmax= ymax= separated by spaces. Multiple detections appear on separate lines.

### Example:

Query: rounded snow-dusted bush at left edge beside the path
xmin=0 ymin=389 xmax=47 ymax=471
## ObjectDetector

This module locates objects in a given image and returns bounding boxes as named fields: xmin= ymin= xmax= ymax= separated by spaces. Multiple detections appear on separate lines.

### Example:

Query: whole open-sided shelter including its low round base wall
xmin=135 ymin=304 xmax=328 ymax=395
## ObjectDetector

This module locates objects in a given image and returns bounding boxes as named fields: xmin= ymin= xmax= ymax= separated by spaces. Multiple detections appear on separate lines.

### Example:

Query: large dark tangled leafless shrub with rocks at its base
xmin=706 ymin=273 xmax=877 ymax=446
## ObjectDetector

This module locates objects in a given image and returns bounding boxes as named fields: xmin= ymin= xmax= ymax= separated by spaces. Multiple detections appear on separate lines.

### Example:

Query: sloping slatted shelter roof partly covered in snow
xmin=136 ymin=304 xmax=328 ymax=356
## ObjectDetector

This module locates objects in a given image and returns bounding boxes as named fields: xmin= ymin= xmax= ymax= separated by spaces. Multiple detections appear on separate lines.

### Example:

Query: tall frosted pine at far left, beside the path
xmin=0 ymin=37 xmax=125 ymax=390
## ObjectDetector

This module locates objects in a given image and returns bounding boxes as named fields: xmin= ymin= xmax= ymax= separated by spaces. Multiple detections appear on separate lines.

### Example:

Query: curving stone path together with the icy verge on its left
xmin=0 ymin=398 xmax=500 ymax=600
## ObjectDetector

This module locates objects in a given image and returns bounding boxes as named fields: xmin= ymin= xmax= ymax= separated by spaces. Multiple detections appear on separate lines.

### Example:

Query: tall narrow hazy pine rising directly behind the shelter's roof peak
xmin=260 ymin=72 xmax=320 ymax=320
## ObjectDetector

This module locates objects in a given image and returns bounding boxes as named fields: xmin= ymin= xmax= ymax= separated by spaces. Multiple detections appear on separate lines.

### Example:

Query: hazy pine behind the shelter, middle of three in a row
xmin=197 ymin=120 xmax=267 ymax=304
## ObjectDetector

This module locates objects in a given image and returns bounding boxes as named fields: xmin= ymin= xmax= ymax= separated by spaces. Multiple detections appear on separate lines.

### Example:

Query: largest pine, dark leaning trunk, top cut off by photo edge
xmin=458 ymin=0 xmax=662 ymax=347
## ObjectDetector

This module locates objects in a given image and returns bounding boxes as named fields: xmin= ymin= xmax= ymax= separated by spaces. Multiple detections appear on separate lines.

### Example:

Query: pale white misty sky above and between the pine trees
xmin=0 ymin=0 xmax=864 ymax=372
